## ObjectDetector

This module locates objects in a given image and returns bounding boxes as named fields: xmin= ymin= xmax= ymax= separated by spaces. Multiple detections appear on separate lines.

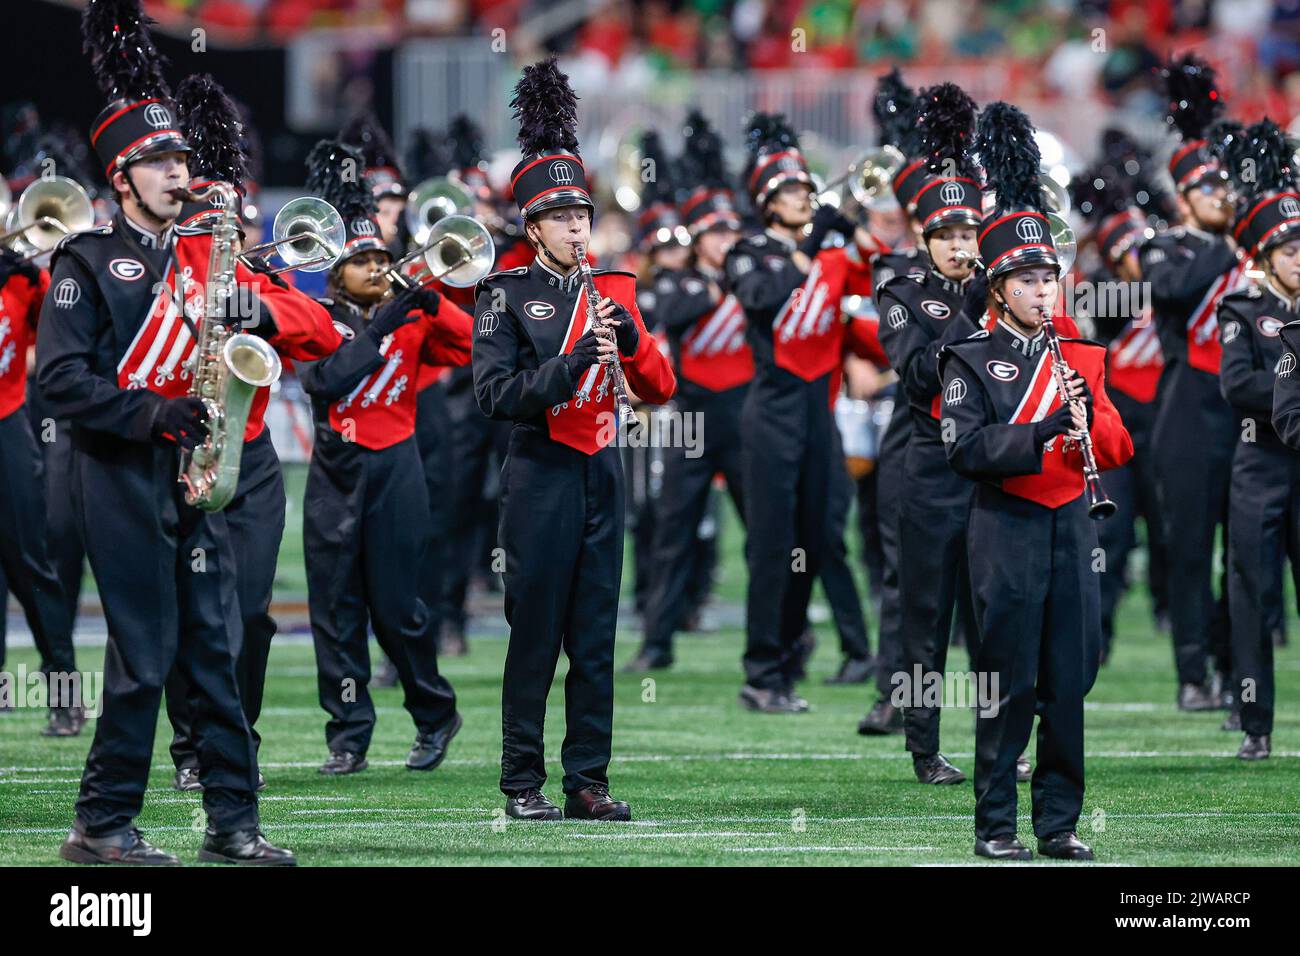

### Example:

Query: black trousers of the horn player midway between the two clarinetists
xmin=741 ymin=369 xmax=835 ymax=691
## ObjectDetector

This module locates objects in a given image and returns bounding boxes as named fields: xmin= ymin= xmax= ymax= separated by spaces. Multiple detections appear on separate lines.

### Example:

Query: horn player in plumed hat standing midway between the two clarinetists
xmin=727 ymin=113 xmax=878 ymax=714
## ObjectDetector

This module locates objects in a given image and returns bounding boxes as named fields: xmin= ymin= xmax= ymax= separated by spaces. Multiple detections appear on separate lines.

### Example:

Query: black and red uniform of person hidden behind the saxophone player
xmin=166 ymin=222 xmax=343 ymax=770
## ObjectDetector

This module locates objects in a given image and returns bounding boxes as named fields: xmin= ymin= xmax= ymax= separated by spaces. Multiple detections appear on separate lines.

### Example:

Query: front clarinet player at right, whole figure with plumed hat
xmin=939 ymin=103 xmax=1132 ymax=860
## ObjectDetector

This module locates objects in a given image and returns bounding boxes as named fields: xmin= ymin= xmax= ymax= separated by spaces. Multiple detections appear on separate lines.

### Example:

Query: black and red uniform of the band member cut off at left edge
xmin=0 ymin=260 xmax=81 ymax=706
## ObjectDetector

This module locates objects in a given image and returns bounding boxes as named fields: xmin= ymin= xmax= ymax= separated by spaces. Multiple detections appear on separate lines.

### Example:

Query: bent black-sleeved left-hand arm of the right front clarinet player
xmin=940 ymin=352 xmax=1069 ymax=481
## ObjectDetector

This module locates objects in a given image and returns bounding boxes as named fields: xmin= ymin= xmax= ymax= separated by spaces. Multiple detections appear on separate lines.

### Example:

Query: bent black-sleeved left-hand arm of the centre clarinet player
xmin=473 ymin=289 xmax=592 ymax=421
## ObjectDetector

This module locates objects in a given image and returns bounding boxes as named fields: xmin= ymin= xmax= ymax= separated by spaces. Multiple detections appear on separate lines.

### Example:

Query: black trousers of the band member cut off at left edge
xmin=0 ymin=406 xmax=81 ymax=681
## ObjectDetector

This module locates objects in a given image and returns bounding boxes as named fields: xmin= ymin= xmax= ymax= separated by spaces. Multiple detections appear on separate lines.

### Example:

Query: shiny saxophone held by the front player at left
xmin=174 ymin=182 xmax=281 ymax=511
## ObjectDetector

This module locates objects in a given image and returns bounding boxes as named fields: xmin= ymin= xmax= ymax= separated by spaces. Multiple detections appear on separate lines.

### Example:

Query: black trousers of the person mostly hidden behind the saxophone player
xmin=166 ymin=429 xmax=285 ymax=769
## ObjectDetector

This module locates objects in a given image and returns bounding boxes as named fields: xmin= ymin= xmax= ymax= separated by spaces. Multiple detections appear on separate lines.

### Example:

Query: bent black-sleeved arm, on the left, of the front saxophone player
xmin=36 ymin=251 xmax=166 ymax=442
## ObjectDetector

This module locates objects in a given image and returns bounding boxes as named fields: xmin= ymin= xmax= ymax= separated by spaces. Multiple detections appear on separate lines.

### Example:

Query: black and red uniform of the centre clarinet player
xmin=473 ymin=257 xmax=676 ymax=795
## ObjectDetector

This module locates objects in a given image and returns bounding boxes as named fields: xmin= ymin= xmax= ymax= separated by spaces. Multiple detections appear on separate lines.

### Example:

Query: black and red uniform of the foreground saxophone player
xmin=36 ymin=212 xmax=266 ymax=836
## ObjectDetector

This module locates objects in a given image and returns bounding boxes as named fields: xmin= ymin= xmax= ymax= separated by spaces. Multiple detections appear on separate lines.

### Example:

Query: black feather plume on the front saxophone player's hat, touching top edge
xmin=82 ymin=0 xmax=172 ymax=101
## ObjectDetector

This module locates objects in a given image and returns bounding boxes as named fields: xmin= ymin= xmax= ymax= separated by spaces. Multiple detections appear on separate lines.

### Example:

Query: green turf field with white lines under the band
xmin=0 ymin=465 xmax=1300 ymax=866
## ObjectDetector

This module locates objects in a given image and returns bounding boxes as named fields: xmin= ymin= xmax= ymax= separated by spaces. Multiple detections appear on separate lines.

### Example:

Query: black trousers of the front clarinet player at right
xmin=967 ymin=484 xmax=1101 ymax=840
